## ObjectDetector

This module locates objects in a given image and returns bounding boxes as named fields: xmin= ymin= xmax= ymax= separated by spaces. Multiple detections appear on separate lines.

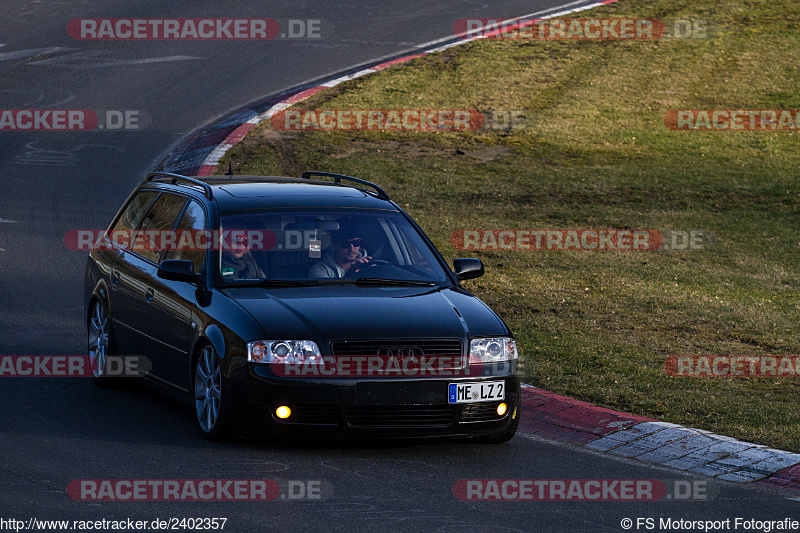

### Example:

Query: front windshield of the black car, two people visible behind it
xmin=219 ymin=211 xmax=449 ymax=285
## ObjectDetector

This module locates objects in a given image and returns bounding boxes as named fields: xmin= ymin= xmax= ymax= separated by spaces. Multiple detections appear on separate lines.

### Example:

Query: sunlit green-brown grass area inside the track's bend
xmin=220 ymin=0 xmax=800 ymax=452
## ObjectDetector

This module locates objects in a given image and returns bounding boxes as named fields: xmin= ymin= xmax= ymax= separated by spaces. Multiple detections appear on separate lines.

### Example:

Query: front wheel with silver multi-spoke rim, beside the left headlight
xmin=194 ymin=345 xmax=232 ymax=441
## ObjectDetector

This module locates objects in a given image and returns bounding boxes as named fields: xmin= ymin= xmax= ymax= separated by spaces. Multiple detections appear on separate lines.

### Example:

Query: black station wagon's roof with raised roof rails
xmin=145 ymin=173 xmax=397 ymax=212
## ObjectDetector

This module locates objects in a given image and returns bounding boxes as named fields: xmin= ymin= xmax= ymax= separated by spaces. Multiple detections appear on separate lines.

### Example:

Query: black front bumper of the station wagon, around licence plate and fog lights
xmin=231 ymin=365 xmax=520 ymax=438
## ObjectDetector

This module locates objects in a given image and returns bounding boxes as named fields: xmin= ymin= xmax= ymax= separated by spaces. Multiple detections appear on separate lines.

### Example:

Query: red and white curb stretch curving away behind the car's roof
xmin=161 ymin=0 xmax=617 ymax=176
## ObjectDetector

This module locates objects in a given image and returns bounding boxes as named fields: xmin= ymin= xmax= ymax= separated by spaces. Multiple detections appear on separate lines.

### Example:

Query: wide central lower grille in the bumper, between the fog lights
xmin=344 ymin=405 xmax=456 ymax=427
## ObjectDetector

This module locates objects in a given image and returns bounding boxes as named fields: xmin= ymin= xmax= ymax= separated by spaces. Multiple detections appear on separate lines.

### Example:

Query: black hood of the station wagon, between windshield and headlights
xmin=225 ymin=286 xmax=510 ymax=344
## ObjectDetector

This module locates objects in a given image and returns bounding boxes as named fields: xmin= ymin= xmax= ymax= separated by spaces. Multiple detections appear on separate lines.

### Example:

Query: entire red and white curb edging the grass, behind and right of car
xmin=161 ymin=0 xmax=800 ymax=490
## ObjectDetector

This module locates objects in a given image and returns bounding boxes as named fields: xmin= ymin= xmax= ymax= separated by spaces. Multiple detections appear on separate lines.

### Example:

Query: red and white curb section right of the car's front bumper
xmin=520 ymin=385 xmax=800 ymax=490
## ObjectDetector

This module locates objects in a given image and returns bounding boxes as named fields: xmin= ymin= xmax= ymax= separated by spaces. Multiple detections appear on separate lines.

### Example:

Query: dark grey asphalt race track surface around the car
xmin=0 ymin=0 xmax=798 ymax=533
